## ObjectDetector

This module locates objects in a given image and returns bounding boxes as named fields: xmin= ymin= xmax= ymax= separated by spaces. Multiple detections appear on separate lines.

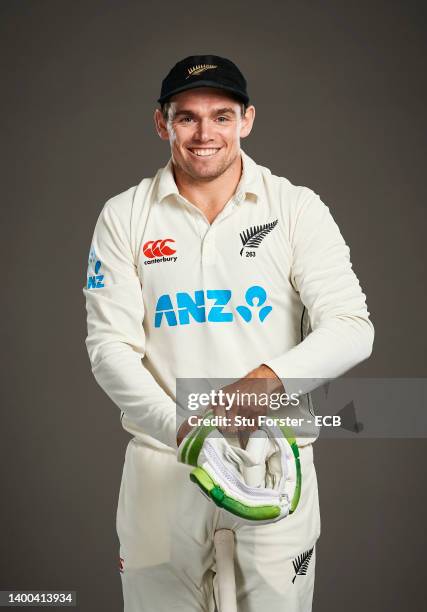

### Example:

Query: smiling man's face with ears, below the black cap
xmin=155 ymin=87 xmax=255 ymax=181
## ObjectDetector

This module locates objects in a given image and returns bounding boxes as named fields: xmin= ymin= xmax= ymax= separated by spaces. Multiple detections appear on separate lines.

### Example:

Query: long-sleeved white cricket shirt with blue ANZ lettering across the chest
xmin=83 ymin=151 xmax=374 ymax=448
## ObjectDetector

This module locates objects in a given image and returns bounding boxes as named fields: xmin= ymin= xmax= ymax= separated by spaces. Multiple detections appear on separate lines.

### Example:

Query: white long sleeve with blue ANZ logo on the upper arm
xmin=83 ymin=188 xmax=176 ymax=448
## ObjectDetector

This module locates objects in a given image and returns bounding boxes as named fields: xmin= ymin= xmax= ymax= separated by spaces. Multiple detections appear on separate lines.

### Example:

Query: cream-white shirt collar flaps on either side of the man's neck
xmin=157 ymin=149 xmax=262 ymax=202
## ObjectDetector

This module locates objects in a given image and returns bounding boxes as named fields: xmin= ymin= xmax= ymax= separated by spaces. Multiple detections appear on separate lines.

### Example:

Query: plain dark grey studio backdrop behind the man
xmin=0 ymin=0 xmax=427 ymax=612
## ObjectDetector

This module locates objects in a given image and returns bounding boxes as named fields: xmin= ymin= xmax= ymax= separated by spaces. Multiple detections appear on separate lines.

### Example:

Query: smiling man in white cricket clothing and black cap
xmin=84 ymin=56 xmax=373 ymax=612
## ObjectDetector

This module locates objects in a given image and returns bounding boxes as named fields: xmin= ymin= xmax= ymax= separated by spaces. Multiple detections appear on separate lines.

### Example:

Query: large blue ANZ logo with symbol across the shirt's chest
xmin=154 ymin=285 xmax=273 ymax=327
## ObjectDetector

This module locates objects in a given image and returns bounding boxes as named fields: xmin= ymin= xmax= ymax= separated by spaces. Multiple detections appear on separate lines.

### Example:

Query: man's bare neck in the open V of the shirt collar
xmin=173 ymin=155 xmax=242 ymax=223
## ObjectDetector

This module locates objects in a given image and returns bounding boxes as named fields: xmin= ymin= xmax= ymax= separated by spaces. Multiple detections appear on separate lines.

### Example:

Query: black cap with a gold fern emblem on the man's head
xmin=157 ymin=55 xmax=249 ymax=105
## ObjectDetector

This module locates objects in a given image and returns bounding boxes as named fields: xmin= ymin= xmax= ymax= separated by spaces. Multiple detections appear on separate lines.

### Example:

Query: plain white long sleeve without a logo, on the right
xmin=265 ymin=188 xmax=374 ymax=394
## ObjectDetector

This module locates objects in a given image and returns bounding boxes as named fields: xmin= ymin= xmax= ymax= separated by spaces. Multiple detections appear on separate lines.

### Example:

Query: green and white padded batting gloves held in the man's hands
xmin=178 ymin=413 xmax=301 ymax=524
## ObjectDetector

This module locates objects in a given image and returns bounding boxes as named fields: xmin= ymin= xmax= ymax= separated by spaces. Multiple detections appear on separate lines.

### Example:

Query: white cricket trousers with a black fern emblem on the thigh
xmin=117 ymin=438 xmax=320 ymax=612
